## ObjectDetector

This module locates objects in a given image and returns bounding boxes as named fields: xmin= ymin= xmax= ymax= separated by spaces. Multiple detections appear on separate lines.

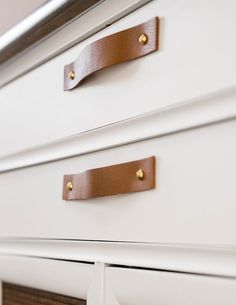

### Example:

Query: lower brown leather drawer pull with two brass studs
xmin=63 ymin=157 xmax=155 ymax=200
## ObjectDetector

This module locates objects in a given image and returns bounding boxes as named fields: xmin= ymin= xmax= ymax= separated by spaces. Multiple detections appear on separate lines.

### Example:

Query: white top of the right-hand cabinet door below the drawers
xmin=106 ymin=268 xmax=236 ymax=305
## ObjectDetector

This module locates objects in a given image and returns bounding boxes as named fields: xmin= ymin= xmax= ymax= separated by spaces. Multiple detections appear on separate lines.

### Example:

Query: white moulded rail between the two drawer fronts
xmin=0 ymin=84 xmax=236 ymax=172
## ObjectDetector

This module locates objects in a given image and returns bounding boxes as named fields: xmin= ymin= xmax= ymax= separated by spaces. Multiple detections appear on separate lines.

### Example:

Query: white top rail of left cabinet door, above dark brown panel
xmin=0 ymin=255 xmax=95 ymax=298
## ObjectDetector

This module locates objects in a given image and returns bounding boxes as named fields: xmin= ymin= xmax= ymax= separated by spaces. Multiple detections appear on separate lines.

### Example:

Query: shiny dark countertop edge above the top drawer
xmin=0 ymin=0 xmax=104 ymax=64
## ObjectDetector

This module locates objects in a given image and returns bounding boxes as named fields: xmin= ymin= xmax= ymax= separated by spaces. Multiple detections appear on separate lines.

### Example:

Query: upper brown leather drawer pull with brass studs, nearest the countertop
xmin=64 ymin=17 xmax=159 ymax=90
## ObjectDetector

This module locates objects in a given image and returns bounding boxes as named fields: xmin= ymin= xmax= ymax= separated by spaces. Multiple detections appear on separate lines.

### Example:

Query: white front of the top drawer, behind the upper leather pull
xmin=0 ymin=0 xmax=236 ymax=156
